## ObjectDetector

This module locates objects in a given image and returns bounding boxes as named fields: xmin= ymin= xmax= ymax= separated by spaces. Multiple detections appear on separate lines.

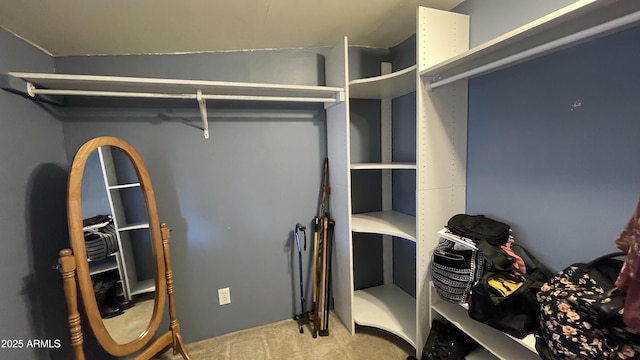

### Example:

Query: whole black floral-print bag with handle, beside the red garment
xmin=536 ymin=253 xmax=640 ymax=359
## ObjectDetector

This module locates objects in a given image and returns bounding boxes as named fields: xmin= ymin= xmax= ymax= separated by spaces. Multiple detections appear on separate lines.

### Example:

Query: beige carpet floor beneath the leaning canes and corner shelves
xmin=159 ymin=314 xmax=415 ymax=360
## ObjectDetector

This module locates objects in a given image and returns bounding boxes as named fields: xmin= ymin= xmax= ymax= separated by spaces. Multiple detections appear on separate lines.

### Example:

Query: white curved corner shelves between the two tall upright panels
xmin=349 ymin=57 xmax=417 ymax=347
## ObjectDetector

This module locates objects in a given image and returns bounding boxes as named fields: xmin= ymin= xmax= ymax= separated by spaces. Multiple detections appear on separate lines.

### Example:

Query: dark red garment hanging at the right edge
xmin=615 ymin=201 xmax=640 ymax=332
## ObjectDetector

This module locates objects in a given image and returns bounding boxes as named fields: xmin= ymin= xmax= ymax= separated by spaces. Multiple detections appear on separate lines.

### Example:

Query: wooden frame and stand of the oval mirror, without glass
xmin=59 ymin=136 xmax=189 ymax=360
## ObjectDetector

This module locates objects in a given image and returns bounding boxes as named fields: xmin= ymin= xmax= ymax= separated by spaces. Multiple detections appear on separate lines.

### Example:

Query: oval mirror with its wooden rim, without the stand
xmin=68 ymin=137 xmax=166 ymax=356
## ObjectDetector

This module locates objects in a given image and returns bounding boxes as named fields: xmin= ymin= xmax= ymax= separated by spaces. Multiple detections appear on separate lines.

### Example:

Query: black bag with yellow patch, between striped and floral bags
xmin=468 ymin=244 xmax=553 ymax=339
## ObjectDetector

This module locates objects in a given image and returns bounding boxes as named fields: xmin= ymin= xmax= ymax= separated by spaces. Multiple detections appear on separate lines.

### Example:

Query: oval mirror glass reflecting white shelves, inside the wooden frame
xmin=82 ymin=146 xmax=156 ymax=344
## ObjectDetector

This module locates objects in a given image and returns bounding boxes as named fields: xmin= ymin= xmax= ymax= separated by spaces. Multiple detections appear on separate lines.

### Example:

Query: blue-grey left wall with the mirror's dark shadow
xmin=0 ymin=29 xmax=78 ymax=359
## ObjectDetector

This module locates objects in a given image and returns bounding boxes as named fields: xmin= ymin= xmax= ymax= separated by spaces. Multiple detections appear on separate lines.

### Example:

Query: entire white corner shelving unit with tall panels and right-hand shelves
xmin=327 ymin=0 xmax=640 ymax=359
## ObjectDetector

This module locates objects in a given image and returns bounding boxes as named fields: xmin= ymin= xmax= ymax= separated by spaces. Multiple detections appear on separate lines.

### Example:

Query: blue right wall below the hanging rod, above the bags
xmin=467 ymin=28 xmax=640 ymax=270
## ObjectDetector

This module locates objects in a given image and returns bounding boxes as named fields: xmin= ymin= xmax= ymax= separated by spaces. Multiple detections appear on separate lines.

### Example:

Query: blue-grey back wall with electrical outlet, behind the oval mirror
xmin=55 ymin=48 xmax=388 ymax=342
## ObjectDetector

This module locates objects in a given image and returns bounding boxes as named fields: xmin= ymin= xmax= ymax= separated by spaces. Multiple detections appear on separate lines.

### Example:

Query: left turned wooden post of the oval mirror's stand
xmin=58 ymin=249 xmax=84 ymax=360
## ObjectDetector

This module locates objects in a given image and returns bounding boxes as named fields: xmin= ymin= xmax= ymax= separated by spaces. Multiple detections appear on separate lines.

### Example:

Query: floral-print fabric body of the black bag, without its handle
xmin=537 ymin=265 xmax=640 ymax=360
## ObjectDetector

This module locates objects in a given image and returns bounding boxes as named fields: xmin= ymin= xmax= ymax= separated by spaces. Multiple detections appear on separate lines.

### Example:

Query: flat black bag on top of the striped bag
xmin=447 ymin=214 xmax=511 ymax=246
